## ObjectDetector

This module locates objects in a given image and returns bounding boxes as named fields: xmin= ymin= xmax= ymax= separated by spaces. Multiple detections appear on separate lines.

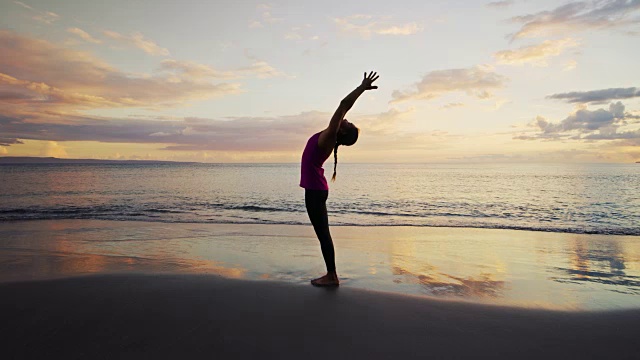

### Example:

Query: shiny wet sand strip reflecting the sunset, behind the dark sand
xmin=0 ymin=220 xmax=640 ymax=310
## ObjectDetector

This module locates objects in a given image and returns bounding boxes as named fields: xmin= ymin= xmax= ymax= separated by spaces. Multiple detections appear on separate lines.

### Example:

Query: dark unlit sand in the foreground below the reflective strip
xmin=0 ymin=274 xmax=640 ymax=359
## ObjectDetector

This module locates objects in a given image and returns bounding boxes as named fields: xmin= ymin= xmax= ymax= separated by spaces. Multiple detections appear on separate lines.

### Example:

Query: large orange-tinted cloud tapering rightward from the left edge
xmin=0 ymin=30 xmax=242 ymax=110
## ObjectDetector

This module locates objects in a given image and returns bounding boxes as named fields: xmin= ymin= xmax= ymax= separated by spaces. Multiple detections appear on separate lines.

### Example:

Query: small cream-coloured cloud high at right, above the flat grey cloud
xmin=493 ymin=38 xmax=578 ymax=66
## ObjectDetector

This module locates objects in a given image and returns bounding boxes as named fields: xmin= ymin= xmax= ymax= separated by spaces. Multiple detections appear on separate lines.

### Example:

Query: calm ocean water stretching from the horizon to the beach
xmin=0 ymin=161 xmax=640 ymax=236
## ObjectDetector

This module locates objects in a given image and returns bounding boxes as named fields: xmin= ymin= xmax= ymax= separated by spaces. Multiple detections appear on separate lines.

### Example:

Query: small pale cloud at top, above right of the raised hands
xmin=333 ymin=15 xmax=422 ymax=38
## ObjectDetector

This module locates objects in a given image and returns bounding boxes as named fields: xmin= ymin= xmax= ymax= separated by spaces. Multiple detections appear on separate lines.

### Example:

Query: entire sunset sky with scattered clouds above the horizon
xmin=0 ymin=0 xmax=640 ymax=163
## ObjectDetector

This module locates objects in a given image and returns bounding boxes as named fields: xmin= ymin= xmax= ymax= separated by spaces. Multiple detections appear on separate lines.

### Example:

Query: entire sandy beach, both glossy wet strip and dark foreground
xmin=0 ymin=220 xmax=640 ymax=359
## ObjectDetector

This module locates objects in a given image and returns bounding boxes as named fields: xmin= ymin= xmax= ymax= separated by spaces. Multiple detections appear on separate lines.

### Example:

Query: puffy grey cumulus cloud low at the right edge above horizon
xmin=514 ymin=101 xmax=640 ymax=140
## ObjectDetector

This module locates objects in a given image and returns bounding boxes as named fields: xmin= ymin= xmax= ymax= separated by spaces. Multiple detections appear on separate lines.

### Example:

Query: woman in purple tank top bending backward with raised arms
xmin=300 ymin=71 xmax=378 ymax=286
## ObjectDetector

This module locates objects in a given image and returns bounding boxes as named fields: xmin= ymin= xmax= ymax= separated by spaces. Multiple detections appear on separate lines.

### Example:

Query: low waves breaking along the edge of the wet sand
xmin=0 ymin=205 xmax=640 ymax=236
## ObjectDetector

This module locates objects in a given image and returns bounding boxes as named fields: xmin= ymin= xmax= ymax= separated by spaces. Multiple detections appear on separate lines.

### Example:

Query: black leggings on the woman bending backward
xmin=304 ymin=189 xmax=336 ymax=272
